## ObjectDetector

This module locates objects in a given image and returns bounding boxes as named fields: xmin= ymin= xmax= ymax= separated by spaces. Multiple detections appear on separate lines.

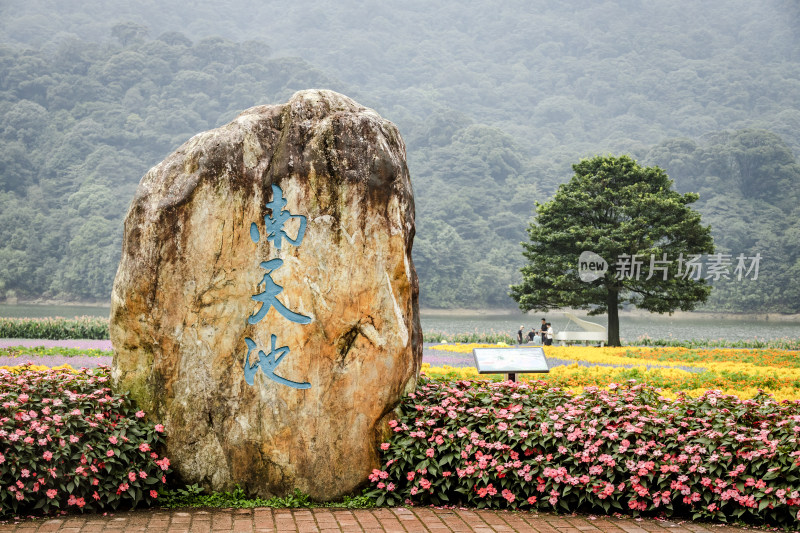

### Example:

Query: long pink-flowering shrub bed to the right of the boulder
xmin=370 ymin=378 xmax=800 ymax=528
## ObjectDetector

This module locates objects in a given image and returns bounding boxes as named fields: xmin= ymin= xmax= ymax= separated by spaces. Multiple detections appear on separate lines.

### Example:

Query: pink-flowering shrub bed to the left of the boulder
xmin=0 ymin=367 xmax=170 ymax=516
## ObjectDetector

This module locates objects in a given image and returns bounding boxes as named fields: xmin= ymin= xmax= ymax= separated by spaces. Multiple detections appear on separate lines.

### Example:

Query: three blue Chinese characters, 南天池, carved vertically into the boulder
xmin=244 ymin=185 xmax=311 ymax=389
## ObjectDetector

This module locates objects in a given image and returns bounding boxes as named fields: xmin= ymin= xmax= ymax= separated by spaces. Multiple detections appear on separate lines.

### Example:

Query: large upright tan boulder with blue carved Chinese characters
xmin=110 ymin=90 xmax=422 ymax=499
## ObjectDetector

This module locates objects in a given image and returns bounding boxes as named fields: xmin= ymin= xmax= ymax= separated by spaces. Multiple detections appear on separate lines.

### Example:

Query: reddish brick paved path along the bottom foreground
xmin=0 ymin=508 xmax=764 ymax=533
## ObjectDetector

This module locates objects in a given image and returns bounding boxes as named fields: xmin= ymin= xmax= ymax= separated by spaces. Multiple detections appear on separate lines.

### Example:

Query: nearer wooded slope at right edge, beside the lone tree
xmin=647 ymin=130 xmax=800 ymax=313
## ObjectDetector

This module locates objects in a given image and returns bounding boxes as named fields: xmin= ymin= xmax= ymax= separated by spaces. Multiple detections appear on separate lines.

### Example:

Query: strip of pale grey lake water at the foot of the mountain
xmin=0 ymin=304 xmax=800 ymax=341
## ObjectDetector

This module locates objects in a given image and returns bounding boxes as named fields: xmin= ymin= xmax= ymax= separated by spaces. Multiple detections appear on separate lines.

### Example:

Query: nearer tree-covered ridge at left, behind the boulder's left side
xmin=0 ymin=33 xmax=340 ymax=300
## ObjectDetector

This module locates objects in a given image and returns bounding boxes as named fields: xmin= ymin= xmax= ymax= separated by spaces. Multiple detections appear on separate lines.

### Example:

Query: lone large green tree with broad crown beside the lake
xmin=510 ymin=155 xmax=720 ymax=346
